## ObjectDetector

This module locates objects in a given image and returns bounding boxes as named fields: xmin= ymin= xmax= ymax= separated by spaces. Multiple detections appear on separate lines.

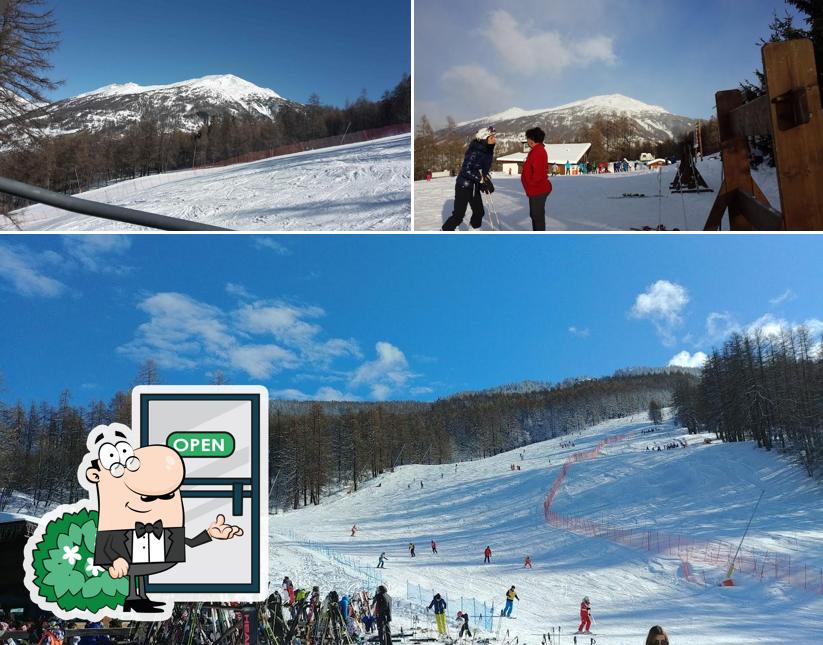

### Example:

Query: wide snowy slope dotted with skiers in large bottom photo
xmin=271 ymin=415 xmax=823 ymax=645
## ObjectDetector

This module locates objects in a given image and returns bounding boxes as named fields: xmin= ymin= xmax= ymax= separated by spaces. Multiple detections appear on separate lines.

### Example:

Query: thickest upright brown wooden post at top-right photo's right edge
xmin=763 ymin=40 xmax=823 ymax=231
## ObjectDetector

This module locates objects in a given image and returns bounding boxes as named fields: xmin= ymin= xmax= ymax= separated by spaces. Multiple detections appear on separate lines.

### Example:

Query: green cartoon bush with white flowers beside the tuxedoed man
xmin=32 ymin=509 xmax=129 ymax=612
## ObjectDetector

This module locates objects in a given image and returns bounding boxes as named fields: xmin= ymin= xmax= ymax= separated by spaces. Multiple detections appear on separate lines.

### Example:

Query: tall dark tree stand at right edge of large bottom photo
xmin=673 ymin=327 xmax=823 ymax=476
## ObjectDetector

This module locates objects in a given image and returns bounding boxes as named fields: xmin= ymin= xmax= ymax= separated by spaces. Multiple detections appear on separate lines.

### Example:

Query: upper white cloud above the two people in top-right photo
xmin=481 ymin=9 xmax=617 ymax=76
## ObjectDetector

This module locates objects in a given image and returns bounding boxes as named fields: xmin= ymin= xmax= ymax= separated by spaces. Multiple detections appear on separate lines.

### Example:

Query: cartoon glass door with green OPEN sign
xmin=132 ymin=385 xmax=269 ymax=602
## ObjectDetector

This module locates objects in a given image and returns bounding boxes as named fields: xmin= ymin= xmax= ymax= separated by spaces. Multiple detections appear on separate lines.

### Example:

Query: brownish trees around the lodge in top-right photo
xmin=414 ymin=115 xmax=720 ymax=181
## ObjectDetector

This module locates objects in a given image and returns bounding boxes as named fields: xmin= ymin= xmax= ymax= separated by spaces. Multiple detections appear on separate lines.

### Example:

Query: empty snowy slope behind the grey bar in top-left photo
xmin=8 ymin=135 xmax=411 ymax=231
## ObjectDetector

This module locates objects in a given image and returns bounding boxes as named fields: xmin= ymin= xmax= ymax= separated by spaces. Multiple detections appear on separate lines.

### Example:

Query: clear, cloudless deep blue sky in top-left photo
xmin=46 ymin=0 xmax=411 ymax=105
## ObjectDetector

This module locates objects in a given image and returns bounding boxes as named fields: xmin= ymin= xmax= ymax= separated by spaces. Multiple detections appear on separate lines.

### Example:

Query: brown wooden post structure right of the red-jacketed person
xmin=704 ymin=39 xmax=823 ymax=231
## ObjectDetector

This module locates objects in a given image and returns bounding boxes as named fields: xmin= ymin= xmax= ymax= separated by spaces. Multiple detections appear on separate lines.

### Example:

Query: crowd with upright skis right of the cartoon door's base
xmin=280 ymin=576 xmax=392 ymax=645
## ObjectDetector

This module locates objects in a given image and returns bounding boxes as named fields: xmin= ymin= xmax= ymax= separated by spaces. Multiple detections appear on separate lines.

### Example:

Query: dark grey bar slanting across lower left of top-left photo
xmin=0 ymin=177 xmax=229 ymax=231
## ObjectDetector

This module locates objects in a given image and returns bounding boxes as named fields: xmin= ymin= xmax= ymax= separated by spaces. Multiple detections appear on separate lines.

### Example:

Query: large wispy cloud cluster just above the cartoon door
xmin=118 ymin=284 xmax=415 ymax=400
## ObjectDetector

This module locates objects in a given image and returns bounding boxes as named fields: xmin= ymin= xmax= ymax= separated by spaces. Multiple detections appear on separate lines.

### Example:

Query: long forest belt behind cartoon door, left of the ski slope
xmin=0 ymin=368 xmax=694 ymax=510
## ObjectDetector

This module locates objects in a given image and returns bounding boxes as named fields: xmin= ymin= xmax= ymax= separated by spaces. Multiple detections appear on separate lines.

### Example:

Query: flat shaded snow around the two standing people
xmin=414 ymin=158 xmax=780 ymax=231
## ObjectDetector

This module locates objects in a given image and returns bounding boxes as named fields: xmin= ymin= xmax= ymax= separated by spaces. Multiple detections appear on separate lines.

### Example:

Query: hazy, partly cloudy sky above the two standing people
xmin=414 ymin=0 xmax=800 ymax=125
